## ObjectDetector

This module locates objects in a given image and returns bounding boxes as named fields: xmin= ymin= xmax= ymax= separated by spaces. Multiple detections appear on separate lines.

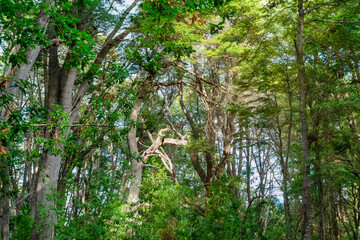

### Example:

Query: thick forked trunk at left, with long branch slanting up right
xmin=28 ymin=11 xmax=134 ymax=236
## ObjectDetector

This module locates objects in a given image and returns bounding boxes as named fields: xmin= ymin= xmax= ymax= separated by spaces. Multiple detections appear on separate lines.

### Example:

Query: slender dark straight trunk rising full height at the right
xmin=296 ymin=0 xmax=312 ymax=240
